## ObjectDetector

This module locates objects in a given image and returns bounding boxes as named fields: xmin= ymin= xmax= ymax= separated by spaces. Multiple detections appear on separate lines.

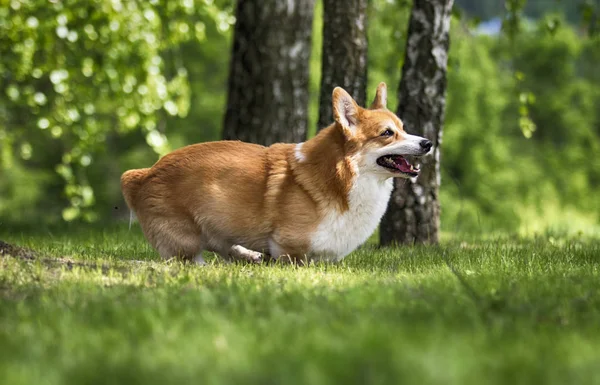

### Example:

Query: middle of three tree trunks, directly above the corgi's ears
xmin=317 ymin=0 xmax=367 ymax=130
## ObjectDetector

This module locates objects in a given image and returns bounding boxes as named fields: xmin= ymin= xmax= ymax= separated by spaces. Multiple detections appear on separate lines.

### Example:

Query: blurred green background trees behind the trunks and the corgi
xmin=0 ymin=0 xmax=600 ymax=237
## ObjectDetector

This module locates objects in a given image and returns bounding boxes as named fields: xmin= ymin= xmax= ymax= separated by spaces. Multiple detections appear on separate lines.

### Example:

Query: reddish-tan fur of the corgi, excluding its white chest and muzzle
xmin=121 ymin=86 xmax=414 ymax=259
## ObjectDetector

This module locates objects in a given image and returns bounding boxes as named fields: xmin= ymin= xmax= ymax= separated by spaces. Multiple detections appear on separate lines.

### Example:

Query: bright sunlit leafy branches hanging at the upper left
xmin=0 ymin=0 xmax=232 ymax=220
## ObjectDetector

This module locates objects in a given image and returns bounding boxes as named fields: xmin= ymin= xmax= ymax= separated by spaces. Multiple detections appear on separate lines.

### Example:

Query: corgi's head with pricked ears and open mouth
xmin=333 ymin=83 xmax=433 ymax=178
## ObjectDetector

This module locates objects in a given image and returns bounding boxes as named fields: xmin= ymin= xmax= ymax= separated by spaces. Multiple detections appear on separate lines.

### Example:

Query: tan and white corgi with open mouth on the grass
xmin=121 ymin=83 xmax=432 ymax=264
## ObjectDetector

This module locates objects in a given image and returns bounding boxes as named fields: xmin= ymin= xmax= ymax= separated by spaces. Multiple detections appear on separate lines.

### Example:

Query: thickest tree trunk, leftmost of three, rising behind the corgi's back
xmin=223 ymin=0 xmax=314 ymax=145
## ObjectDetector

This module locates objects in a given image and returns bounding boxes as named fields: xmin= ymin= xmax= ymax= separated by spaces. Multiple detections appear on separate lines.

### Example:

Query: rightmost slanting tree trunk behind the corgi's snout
xmin=380 ymin=0 xmax=453 ymax=245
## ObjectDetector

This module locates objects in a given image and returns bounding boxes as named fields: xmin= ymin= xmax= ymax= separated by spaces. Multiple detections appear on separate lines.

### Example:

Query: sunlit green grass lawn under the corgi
xmin=0 ymin=227 xmax=600 ymax=385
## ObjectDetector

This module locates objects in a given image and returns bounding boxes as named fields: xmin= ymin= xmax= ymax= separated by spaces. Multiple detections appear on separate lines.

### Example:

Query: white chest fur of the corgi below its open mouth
xmin=311 ymin=173 xmax=393 ymax=260
